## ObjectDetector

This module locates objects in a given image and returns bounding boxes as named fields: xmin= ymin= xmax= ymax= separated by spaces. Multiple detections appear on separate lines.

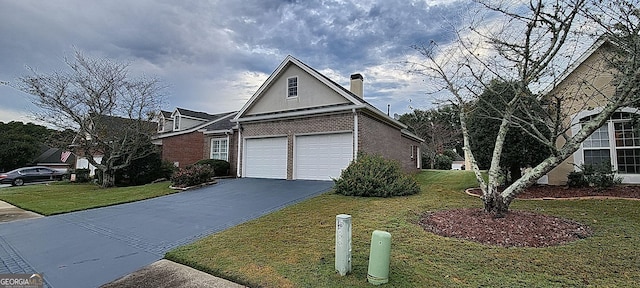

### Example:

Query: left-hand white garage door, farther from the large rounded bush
xmin=243 ymin=137 xmax=287 ymax=179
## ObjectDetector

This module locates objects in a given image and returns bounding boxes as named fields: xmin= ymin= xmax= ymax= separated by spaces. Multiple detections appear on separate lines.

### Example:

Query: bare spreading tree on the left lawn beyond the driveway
xmin=18 ymin=51 xmax=163 ymax=187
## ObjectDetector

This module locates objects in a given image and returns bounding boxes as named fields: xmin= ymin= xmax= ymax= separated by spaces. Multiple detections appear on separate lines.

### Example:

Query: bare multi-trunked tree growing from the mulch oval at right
xmin=414 ymin=0 xmax=640 ymax=217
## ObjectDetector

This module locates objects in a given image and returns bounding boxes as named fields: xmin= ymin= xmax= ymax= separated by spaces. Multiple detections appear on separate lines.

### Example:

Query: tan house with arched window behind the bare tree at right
xmin=538 ymin=39 xmax=640 ymax=185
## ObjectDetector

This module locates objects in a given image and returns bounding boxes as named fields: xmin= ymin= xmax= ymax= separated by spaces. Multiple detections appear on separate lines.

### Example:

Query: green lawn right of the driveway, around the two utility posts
xmin=166 ymin=171 xmax=640 ymax=287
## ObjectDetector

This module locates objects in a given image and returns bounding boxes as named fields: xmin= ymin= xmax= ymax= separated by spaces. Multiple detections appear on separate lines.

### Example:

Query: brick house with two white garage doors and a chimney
xmin=231 ymin=56 xmax=423 ymax=180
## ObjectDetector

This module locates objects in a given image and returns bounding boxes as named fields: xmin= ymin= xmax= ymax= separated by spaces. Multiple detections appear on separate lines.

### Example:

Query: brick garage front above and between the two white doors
xmin=240 ymin=112 xmax=353 ymax=179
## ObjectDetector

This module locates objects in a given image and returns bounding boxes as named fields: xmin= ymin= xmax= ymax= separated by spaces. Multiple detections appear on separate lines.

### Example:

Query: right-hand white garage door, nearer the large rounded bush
xmin=294 ymin=133 xmax=353 ymax=180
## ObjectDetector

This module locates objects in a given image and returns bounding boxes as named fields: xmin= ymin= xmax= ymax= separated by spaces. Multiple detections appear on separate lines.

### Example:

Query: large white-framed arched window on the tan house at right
xmin=582 ymin=112 xmax=640 ymax=174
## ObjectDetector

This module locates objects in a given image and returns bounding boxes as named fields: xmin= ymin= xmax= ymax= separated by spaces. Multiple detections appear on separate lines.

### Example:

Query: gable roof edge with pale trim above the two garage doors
xmin=232 ymin=55 xmax=407 ymax=129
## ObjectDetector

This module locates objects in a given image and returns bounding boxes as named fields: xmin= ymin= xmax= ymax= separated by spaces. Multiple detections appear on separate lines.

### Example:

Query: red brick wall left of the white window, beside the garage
xmin=162 ymin=131 xmax=204 ymax=168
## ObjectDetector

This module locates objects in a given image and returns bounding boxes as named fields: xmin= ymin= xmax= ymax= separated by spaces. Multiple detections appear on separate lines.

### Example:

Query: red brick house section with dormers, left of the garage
xmin=153 ymin=108 xmax=237 ymax=174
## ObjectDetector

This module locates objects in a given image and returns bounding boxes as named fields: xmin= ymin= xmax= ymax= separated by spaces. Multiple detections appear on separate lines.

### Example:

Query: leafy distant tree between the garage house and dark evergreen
xmin=398 ymin=106 xmax=462 ymax=168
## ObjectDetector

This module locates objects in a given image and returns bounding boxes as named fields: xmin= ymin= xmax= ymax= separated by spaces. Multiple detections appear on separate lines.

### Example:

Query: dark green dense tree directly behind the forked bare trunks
xmin=468 ymin=81 xmax=551 ymax=183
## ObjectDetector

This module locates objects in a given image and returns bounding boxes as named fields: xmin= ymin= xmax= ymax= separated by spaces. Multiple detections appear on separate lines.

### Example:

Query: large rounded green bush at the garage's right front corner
xmin=333 ymin=153 xmax=420 ymax=197
